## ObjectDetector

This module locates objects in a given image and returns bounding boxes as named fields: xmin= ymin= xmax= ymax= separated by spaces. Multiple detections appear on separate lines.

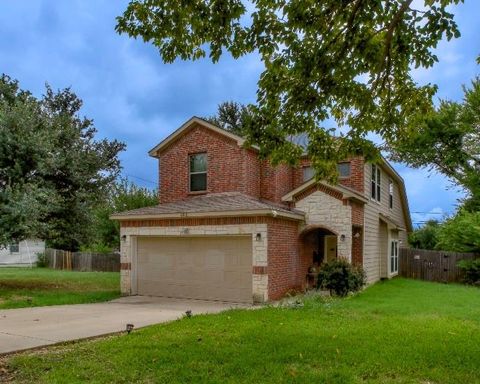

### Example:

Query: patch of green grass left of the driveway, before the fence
xmin=0 ymin=268 xmax=120 ymax=309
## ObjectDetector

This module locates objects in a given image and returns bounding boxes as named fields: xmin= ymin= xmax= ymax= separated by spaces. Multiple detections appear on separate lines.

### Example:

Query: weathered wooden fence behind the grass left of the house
xmin=45 ymin=248 xmax=120 ymax=272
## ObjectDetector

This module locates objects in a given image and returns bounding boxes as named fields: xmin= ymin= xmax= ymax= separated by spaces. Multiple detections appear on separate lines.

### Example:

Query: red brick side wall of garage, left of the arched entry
xmin=267 ymin=220 xmax=305 ymax=300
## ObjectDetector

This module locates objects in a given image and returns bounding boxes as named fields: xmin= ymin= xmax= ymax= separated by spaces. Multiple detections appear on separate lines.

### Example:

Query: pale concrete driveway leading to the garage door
xmin=0 ymin=296 xmax=247 ymax=354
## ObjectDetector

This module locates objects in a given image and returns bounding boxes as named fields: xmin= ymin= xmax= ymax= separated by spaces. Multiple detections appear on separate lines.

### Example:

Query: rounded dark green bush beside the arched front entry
xmin=318 ymin=259 xmax=366 ymax=296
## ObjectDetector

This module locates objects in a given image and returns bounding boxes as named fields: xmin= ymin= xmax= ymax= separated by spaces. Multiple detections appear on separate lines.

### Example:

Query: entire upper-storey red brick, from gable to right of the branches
xmin=159 ymin=124 xmax=364 ymax=207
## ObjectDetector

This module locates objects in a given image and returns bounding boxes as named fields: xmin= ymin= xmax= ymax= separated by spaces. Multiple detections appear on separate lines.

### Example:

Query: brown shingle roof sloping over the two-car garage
xmin=111 ymin=192 xmax=304 ymax=219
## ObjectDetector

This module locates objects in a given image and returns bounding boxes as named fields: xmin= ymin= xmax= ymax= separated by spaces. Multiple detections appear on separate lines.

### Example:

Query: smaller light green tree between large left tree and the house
xmin=87 ymin=179 xmax=158 ymax=250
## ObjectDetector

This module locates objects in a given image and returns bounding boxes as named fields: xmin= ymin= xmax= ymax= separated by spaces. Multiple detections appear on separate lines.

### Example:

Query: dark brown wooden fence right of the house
xmin=398 ymin=248 xmax=478 ymax=283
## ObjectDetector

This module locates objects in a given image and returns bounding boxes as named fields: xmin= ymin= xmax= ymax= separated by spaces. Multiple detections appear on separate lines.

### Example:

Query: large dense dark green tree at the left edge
xmin=0 ymin=75 xmax=125 ymax=250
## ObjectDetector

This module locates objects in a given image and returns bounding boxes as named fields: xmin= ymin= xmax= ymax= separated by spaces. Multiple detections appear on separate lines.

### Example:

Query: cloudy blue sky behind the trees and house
xmin=0 ymin=0 xmax=480 ymax=223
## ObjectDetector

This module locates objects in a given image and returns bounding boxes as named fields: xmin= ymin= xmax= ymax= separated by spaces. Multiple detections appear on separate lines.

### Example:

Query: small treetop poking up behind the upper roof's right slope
xmin=205 ymin=101 xmax=249 ymax=136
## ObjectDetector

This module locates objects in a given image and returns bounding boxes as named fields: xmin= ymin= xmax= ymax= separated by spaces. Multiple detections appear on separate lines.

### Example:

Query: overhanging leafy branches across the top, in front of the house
xmin=116 ymin=0 xmax=461 ymax=180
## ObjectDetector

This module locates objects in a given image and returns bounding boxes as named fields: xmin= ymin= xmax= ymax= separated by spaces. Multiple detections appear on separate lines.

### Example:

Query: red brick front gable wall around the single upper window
xmin=159 ymin=125 xmax=260 ymax=203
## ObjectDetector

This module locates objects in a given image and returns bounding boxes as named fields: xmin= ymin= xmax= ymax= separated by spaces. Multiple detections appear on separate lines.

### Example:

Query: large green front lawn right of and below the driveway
xmin=0 ymin=279 xmax=480 ymax=384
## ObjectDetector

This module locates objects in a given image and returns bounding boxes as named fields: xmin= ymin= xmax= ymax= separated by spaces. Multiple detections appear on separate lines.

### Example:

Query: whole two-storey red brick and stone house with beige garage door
xmin=112 ymin=117 xmax=412 ymax=302
